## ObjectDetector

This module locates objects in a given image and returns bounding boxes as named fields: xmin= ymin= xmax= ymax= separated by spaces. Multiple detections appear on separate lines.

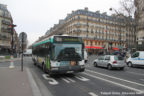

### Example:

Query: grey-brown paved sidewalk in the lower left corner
xmin=0 ymin=68 xmax=33 ymax=96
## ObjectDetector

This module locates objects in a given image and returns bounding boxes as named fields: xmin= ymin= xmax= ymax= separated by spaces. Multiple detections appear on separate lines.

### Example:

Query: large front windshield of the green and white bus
xmin=54 ymin=44 xmax=83 ymax=61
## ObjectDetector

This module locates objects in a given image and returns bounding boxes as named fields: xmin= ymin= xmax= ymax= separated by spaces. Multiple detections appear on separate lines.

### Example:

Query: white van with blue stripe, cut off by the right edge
xmin=126 ymin=51 xmax=144 ymax=67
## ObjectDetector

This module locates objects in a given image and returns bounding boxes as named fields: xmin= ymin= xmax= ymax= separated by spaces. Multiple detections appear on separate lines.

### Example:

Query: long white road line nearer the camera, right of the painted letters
xmin=83 ymin=73 xmax=143 ymax=94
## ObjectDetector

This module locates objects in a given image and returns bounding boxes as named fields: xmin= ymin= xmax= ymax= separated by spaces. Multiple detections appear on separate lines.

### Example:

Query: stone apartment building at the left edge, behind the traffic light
xmin=0 ymin=4 xmax=18 ymax=55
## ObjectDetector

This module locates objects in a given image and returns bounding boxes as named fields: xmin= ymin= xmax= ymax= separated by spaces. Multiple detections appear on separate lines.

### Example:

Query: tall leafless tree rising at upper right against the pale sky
xmin=110 ymin=0 xmax=136 ymax=47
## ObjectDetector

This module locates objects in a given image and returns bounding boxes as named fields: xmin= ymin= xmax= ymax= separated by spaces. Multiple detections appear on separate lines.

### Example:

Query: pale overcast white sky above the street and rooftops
xmin=0 ymin=0 xmax=120 ymax=45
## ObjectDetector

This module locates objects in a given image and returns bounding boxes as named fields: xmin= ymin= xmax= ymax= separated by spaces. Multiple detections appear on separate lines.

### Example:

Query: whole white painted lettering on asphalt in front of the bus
xmin=42 ymin=74 xmax=90 ymax=85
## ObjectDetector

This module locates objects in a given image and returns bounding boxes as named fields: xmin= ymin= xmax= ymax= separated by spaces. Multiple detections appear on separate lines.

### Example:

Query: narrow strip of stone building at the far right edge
xmin=134 ymin=0 xmax=144 ymax=51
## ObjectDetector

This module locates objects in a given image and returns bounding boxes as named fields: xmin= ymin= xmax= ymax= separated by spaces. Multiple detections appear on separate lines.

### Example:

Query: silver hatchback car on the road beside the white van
xmin=93 ymin=55 xmax=126 ymax=70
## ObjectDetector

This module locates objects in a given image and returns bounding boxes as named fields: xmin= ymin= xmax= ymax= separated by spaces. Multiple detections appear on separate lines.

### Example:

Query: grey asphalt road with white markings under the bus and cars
xmin=0 ymin=56 xmax=144 ymax=96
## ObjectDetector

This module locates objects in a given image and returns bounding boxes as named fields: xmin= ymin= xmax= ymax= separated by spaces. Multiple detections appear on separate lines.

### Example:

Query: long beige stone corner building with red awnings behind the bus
xmin=44 ymin=8 xmax=135 ymax=53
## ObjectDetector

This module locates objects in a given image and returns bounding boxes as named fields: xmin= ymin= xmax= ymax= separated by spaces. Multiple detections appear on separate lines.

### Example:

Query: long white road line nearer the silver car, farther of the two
xmin=86 ymin=69 xmax=144 ymax=86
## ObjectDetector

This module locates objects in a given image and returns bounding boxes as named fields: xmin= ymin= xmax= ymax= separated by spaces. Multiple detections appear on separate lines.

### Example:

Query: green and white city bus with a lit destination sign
xmin=32 ymin=35 xmax=85 ymax=74
